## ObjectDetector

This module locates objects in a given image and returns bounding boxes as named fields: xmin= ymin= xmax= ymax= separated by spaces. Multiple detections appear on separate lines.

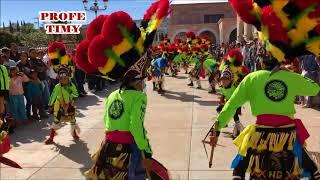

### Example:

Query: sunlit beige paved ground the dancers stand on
xmin=0 ymin=73 xmax=320 ymax=180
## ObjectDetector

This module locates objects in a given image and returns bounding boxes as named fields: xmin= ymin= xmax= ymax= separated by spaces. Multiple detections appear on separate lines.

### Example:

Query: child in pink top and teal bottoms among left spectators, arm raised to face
xmin=9 ymin=67 xmax=29 ymax=125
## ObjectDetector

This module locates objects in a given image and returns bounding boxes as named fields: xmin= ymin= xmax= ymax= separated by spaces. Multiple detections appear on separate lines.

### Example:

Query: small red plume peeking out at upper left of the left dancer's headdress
xmin=86 ymin=15 xmax=108 ymax=40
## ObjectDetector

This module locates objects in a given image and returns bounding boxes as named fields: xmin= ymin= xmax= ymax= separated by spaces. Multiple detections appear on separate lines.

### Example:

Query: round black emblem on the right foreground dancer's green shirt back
xmin=264 ymin=80 xmax=288 ymax=102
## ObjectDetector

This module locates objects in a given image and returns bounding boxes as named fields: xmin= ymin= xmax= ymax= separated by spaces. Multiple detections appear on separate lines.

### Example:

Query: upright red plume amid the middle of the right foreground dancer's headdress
xmin=261 ymin=6 xmax=289 ymax=44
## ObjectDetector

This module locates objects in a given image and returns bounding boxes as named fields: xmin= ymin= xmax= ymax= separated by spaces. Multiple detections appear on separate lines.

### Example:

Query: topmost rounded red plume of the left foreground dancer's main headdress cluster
xmin=101 ymin=11 xmax=135 ymax=45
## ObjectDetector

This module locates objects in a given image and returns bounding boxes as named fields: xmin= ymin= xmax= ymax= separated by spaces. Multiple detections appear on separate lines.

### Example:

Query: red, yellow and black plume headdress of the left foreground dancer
xmin=76 ymin=0 xmax=170 ymax=79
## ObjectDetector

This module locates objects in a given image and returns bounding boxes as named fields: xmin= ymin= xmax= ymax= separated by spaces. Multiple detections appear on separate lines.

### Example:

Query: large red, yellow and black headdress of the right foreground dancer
xmin=230 ymin=0 xmax=320 ymax=62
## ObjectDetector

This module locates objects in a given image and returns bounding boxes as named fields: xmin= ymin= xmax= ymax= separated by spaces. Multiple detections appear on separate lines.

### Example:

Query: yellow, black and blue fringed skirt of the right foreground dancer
xmin=231 ymin=125 xmax=314 ymax=179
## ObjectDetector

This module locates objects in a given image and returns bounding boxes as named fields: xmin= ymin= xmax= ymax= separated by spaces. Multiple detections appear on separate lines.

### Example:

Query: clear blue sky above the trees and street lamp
xmin=0 ymin=0 xmax=155 ymax=26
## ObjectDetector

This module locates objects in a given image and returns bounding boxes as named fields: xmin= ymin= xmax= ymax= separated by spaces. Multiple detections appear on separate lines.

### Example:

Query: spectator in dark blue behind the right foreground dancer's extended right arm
xmin=300 ymin=55 xmax=320 ymax=108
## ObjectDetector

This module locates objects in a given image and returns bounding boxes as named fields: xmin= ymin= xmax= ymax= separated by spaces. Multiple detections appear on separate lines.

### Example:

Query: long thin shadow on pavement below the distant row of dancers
xmin=161 ymin=90 xmax=219 ymax=106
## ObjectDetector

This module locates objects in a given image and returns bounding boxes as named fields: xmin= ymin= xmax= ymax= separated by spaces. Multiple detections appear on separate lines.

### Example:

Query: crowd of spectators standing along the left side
xmin=0 ymin=43 xmax=104 ymax=133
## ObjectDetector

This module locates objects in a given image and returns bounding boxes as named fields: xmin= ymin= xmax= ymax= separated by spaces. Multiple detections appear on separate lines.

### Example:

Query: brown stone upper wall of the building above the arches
xmin=168 ymin=2 xmax=237 ymax=43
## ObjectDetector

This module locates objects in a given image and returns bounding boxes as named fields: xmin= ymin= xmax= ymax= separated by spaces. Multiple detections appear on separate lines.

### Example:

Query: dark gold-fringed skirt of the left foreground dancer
xmin=86 ymin=141 xmax=145 ymax=180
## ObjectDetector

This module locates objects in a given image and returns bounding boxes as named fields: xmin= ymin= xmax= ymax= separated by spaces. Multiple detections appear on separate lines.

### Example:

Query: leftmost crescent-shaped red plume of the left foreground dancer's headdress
xmin=75 ymin=39 xmax=98 ymax=73
